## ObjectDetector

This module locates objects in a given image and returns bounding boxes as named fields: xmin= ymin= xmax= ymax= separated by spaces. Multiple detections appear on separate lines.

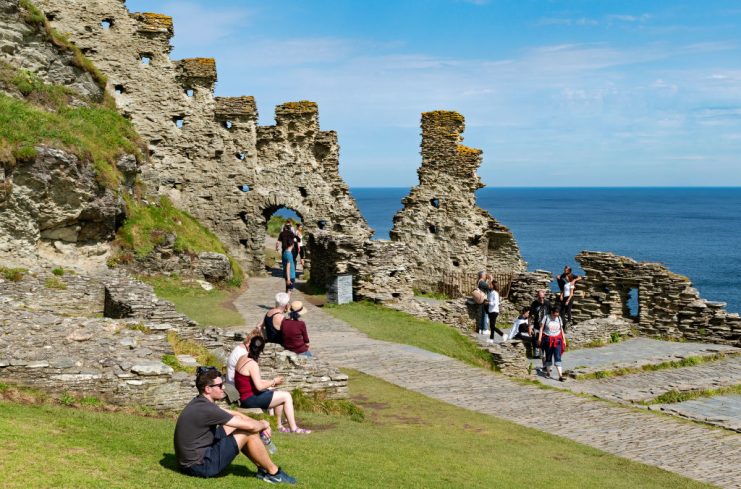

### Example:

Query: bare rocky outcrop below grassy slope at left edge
xmin=0 ymin=146 xmax=125 ymax=255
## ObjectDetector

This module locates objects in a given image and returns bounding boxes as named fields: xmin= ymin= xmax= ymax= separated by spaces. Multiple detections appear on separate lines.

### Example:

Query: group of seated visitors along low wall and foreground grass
xmin=175 ymin=292 xmax=312 ymax=484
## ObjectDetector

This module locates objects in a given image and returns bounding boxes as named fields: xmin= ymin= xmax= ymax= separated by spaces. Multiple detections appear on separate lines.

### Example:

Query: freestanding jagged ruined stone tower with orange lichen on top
xmin=391 ymin=111 xmax=525 ymax=279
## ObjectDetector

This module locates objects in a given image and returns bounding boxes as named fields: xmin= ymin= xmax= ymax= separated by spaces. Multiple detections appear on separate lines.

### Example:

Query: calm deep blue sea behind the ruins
xmin=351 ymin=188 xmax=741 ymax=312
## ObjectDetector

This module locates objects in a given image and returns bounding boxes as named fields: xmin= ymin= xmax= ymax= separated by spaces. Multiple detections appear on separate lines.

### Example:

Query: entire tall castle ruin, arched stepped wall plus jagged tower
xmin=31 ymin=0 xmax=524 ymax=301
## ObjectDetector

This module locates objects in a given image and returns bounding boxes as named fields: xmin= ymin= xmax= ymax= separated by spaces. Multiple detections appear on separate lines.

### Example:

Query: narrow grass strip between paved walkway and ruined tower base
xmin=323 ymin=302 xmax=492 ymax=368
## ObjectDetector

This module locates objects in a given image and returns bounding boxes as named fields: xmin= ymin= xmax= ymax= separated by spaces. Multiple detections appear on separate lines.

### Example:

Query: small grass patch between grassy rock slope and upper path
xmin=145 ymin=277 xmax=244 ymax=328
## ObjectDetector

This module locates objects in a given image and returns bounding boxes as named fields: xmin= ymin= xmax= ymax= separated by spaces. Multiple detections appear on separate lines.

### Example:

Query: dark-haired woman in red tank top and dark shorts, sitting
xmin=234 ymin=336 xmax=311 ymax=434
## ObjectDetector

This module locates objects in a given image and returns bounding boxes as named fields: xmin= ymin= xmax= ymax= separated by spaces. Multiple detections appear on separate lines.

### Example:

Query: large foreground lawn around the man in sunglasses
xmin=0 ymin=372 xmax=708 ymax=489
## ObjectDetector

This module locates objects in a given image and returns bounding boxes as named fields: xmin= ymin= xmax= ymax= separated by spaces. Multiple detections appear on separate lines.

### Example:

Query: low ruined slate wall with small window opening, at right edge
xmin=573 ymin=251 xmax=741 ymax=346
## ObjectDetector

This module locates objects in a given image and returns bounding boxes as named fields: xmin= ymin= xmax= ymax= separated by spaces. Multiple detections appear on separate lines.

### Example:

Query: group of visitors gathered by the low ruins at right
xmin=477 ymin=265 xmax=581 ymax=382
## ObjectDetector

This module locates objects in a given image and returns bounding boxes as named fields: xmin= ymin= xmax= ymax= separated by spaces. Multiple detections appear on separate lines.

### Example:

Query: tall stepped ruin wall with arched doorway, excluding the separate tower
xmin=39 ymin=0 xmax=372 ymax=273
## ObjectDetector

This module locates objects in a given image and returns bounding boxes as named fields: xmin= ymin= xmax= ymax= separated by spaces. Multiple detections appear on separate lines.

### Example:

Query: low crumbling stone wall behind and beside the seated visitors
xmin=0 ymin=269 xmax=348 ymax=409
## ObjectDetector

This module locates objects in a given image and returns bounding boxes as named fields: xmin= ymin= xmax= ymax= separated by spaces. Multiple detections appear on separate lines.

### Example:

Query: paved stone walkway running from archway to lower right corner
xmin=235 ymin=278 xmax=741 ymax=488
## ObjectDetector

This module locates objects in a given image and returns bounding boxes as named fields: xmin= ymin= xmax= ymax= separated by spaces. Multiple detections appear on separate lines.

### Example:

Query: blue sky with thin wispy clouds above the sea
xmin=126 ymin=0 xmax=741 ymax=186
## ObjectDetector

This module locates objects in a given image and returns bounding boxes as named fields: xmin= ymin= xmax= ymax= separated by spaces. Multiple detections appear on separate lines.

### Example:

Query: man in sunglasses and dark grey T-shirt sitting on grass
xmin=175 ymin=367 xmax=296 ymax=484
